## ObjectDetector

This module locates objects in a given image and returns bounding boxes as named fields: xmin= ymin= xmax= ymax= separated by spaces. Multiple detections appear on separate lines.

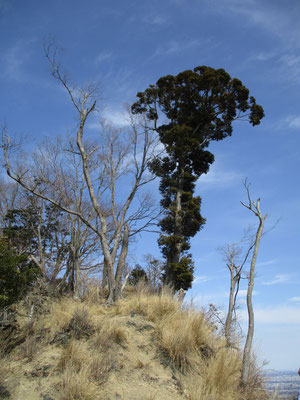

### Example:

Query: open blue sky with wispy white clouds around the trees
xmin=0 ymin=0 xmax=300 ymax=370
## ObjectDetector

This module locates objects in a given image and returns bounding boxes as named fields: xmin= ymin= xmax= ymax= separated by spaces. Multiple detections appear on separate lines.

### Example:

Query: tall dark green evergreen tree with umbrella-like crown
xmin=132 ymin=66 xmax=264 ymax=289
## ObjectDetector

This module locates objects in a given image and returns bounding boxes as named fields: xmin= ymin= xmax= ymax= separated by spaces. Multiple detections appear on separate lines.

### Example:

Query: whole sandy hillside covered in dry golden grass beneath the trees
xmin=0 ymin=288 xmax=266 ymax=400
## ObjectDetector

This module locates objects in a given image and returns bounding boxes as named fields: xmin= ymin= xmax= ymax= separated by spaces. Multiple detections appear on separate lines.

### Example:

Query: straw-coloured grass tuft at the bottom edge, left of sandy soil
xmin=59 ymin=366 xmax=99 ymax=400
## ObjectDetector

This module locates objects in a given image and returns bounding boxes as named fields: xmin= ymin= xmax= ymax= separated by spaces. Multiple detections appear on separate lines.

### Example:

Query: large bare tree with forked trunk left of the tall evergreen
xmin=2 ymin=44 xmax=158 ymax=303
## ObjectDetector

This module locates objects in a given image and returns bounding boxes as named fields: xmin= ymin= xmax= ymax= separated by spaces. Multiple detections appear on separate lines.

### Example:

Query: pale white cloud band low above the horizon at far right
xmin=240 ymin=306 xmax=300 ymax=324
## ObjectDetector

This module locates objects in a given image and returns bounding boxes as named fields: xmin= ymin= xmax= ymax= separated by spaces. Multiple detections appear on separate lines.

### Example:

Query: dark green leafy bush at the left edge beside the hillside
xmin=0 ymin=238 xmax=40 ymax=308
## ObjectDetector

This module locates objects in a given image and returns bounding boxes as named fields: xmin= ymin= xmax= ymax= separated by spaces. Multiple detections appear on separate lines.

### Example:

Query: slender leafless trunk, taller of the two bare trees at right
xmin=241 ymin=180 xmax=267 ymax=385
